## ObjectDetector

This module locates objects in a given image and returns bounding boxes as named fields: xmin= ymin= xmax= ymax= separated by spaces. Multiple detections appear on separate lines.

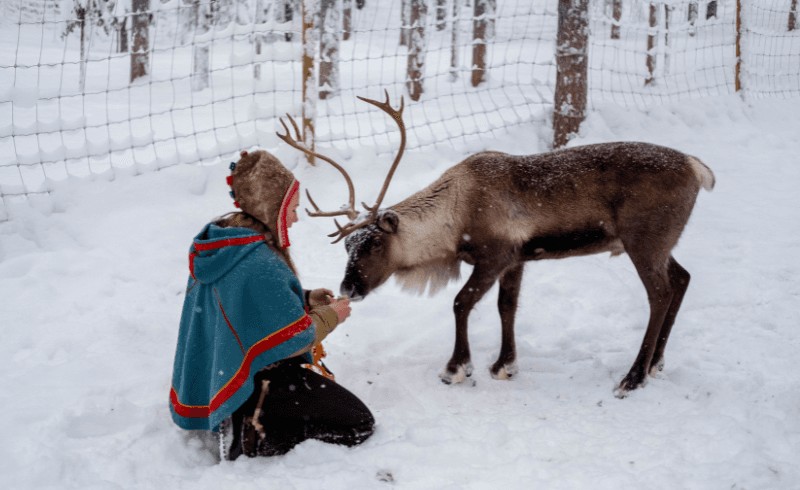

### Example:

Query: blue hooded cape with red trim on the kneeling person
xmin=170 ymin=224 xmax=316 ymax=431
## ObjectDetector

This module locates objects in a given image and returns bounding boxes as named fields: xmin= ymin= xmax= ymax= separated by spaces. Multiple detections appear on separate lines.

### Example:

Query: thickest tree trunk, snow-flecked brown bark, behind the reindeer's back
xmin=553 ymin=0 xmax=589 ymax=148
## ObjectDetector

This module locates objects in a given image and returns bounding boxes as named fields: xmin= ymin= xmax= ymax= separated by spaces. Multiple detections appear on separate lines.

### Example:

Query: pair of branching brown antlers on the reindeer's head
xmin=278 ymin=90 xmax=406 ymax=243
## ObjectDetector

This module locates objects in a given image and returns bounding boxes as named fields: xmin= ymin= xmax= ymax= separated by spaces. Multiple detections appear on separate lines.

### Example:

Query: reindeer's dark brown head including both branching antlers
xmin=278 ymin=91 xmax=406 ymax=301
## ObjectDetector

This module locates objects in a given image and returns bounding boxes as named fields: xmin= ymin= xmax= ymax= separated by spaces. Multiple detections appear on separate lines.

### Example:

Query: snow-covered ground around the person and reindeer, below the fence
xmin=0 ymin=96 xmax=800 ymax=490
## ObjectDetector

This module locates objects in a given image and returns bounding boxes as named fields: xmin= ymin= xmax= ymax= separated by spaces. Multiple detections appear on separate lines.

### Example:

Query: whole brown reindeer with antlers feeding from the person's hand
xmin=278 ymin=92 xmax=714 ymax=398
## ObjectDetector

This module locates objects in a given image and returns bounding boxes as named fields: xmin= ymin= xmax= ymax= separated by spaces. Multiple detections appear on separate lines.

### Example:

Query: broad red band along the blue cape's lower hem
xmin=169 ymin=315 xmax=311 ymax=418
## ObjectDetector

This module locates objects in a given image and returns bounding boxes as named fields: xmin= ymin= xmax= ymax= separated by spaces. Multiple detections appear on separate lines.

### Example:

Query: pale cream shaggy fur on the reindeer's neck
xmin=390 ymin=167 xmax=469 ymax=295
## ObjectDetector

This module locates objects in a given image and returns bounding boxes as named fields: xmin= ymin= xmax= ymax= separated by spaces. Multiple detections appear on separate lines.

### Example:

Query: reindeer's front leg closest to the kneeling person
xmin=439 ymin=263 xmax=498 ymax=384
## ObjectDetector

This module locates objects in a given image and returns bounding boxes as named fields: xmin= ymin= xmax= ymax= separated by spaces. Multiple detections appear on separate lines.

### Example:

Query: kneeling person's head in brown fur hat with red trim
xmin=228 ymin=150 xmax=300 ymax=248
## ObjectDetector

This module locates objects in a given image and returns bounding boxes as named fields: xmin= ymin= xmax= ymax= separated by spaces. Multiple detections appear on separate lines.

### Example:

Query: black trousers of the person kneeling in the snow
xmin=229 ymin=358 xmax=375 ymax=459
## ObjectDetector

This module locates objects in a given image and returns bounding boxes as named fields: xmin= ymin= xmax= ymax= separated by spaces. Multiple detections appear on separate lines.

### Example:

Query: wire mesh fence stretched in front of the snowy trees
xmin=0 ymin=0 xmax=800 ymax=219
